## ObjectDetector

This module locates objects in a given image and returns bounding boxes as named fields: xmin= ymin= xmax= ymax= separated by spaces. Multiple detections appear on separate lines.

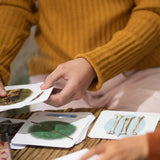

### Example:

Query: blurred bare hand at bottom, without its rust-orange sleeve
xmin=80 ymin=135 xmax=149 ymax=160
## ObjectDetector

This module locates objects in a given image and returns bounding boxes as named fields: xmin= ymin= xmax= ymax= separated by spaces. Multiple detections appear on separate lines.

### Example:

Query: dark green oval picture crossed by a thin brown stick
xmin=28 ymin=121 xmax=76 ymax=139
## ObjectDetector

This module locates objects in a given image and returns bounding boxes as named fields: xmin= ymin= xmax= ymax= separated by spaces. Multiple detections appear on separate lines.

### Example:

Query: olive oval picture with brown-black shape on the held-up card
xmin=0 ymin=88 xmax=33 ymax=105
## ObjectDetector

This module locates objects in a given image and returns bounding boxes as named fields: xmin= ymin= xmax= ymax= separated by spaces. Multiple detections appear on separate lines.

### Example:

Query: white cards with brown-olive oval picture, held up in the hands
xmin=0 ymin=82 xmax=53 ymax=112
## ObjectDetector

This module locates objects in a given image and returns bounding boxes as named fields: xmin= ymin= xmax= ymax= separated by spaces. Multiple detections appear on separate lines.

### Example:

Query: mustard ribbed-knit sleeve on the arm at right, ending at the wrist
xmin=76 ymin=0 xmax=160 ymax=90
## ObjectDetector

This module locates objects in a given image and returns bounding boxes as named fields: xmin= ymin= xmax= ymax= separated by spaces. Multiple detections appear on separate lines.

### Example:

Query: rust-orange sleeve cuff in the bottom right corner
xmin=147 ymin=130 xmax=160 ymax=160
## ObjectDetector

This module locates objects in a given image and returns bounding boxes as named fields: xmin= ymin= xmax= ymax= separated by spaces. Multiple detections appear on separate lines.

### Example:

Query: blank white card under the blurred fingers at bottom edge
xmin=55 ymin=148 xmax=98 ymax=160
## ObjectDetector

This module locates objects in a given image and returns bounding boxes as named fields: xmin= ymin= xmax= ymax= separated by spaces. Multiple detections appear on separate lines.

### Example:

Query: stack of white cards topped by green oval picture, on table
xmin=12 ymin=112 xmax=95 ymax=148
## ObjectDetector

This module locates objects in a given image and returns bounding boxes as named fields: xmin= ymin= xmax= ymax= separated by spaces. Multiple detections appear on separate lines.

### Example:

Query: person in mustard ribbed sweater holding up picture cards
xmin=0 ymin=0 xmax=160 ymax=111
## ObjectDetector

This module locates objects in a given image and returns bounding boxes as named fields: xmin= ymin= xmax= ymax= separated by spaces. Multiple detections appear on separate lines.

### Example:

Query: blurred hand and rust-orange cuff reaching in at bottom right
xmin=80 ymin=130 xmax=160 ymax=160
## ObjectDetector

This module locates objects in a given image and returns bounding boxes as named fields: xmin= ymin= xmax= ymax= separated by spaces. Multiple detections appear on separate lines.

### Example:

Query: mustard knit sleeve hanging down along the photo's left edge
xmin=0 ymin=0 xmax=36 ymax=85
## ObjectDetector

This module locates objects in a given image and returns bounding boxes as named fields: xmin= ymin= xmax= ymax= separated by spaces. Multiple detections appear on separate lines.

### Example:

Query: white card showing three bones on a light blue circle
xmin=88 ymin=110 xmax=160 ymax=139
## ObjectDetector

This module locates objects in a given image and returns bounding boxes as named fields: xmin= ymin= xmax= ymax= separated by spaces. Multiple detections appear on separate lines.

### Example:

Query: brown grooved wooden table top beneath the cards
xmin=10 ymin=109 xmax=160 ymax=160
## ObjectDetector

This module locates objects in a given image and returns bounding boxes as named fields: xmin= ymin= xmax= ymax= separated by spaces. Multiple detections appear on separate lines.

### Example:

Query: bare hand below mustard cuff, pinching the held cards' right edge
xmin=41 ymin=58 xmax=96 ymax=107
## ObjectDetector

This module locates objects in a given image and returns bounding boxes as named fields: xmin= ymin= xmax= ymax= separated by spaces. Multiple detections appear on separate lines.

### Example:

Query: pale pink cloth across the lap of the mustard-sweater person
xmin=30 ymin=68 xmax=160 ymax=112
